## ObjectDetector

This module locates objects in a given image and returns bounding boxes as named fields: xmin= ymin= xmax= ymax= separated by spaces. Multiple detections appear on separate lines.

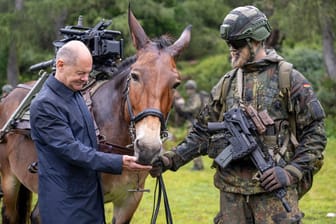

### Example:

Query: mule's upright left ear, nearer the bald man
xmin=128 ymin=4 xmax=150 ymax=50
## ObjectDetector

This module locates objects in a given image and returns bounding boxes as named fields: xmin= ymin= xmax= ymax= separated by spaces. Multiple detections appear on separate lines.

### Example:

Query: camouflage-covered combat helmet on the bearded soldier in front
xmin=220 ymin=5 xmax=271 ymax=42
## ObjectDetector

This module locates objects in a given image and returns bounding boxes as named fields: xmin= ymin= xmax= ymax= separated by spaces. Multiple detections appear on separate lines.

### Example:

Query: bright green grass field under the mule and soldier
xmin=105 ymin=136 xmax=336 ymax=224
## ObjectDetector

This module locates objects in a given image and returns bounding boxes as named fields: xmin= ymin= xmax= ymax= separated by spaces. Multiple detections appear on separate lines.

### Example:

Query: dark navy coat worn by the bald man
xmin=30 ymin=75 xmax=122 ymax=224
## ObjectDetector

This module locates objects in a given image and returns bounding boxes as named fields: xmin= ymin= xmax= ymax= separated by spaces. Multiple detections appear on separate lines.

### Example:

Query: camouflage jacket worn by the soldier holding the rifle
xmin=169 ymin=51 xmax=326 ymax=195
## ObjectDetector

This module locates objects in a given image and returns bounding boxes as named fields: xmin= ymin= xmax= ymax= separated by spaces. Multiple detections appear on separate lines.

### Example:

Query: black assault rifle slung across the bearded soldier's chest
xmin=208 ymin=106 xmax=291 ymax=212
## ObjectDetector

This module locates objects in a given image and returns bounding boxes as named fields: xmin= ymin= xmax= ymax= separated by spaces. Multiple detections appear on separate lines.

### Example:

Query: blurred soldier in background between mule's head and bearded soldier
xmin=174 ymin=80 xmax=204 ymax=170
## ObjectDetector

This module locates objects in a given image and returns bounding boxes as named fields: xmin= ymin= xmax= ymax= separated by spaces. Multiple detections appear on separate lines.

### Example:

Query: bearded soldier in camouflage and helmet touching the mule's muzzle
xmin=151 ymin=6 xmax=327 ymax=224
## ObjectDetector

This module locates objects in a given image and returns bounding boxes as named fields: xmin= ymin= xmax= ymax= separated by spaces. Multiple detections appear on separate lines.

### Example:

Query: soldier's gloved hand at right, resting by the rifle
xmin=260 ymin=166 xmax=294 ymax=192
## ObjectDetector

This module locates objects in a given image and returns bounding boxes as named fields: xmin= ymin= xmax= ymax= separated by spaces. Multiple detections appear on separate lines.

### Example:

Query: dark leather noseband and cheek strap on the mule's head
xmin=125 ymin=75 xmax=168 ymax=144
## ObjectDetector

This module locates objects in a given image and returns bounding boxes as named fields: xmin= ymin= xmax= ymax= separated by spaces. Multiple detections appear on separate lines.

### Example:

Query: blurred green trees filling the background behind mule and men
xmin=0 ymin=0 xmax=336 ymax=95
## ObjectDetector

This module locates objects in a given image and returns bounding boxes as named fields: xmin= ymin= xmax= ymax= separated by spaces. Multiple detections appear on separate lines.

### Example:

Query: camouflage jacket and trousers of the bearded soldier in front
xmin=167 ymin=51 xmax=326 ymax=223
